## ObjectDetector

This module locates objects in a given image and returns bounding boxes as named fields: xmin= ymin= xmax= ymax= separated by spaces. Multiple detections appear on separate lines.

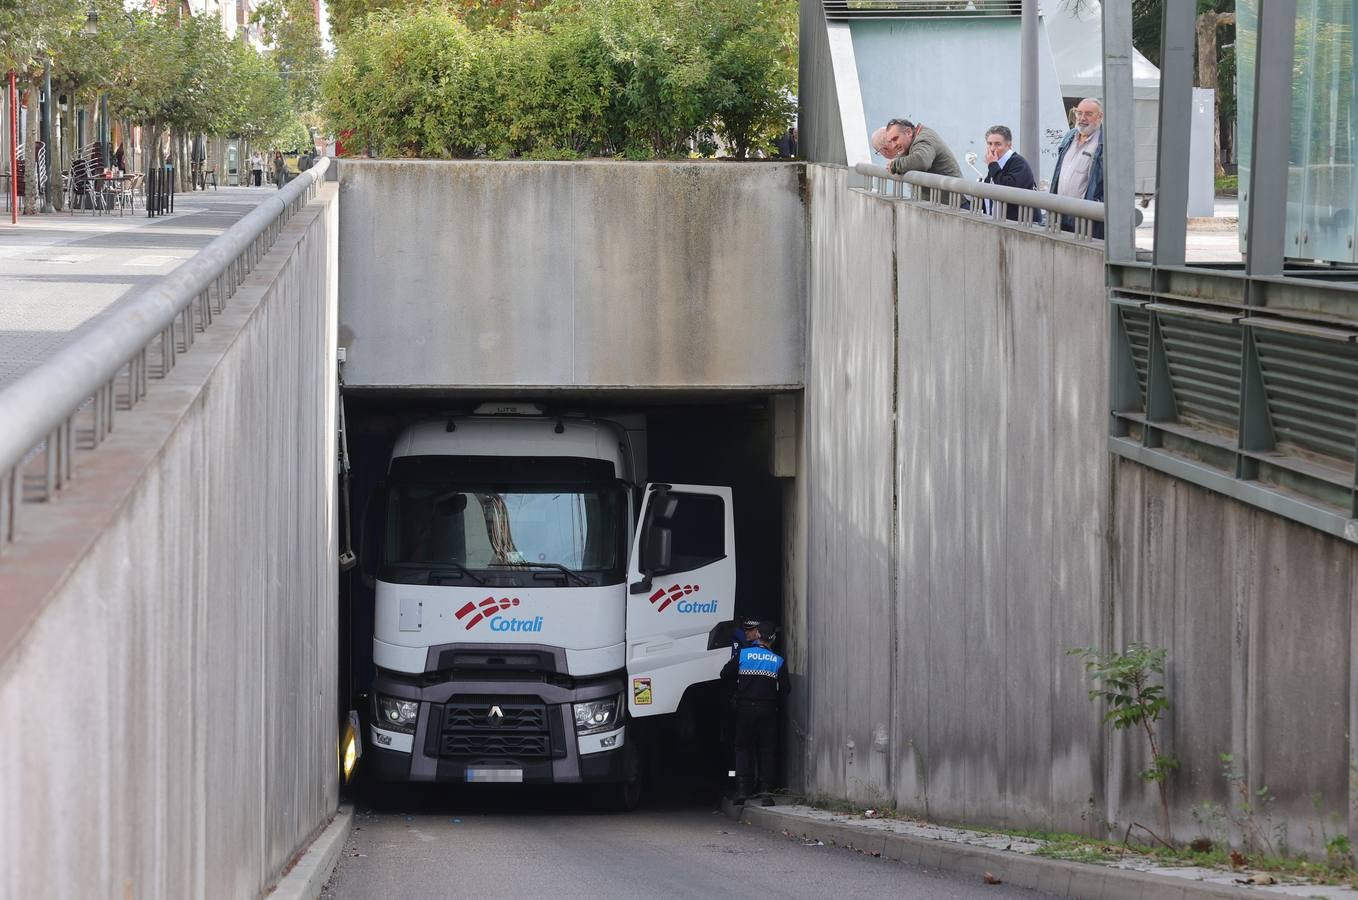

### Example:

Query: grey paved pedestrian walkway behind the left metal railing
xmin=0 ymin=186 xmax=276 ymax=387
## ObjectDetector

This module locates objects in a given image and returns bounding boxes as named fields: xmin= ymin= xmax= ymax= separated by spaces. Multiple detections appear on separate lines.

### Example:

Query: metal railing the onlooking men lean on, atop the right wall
xmin=854 ymin=163 xmax=1104 ymax=240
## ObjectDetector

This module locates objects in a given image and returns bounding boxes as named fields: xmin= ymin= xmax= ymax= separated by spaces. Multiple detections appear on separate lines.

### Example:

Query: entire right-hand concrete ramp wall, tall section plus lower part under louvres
xmin=786 ymin=166 xmax=1358 ymax=854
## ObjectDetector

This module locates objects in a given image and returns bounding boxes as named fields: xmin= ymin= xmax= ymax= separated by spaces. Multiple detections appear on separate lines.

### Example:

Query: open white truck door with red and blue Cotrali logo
xmin=627 ymin=485 xmax=736 ymax=717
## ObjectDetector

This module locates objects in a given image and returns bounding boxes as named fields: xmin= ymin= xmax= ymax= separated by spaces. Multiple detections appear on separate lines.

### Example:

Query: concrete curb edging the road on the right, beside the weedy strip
xmin=722 ymin=804 xmax=1277 ymax=900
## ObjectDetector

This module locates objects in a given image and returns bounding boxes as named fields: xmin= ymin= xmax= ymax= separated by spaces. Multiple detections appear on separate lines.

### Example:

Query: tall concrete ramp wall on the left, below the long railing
xmin=0 ymin=186 xmax=338 ymax=900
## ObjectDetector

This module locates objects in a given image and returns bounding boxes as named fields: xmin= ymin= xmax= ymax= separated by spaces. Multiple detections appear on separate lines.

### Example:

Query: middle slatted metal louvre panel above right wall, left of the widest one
xmin=1157 ymin=315 xmax=1240 ymax=430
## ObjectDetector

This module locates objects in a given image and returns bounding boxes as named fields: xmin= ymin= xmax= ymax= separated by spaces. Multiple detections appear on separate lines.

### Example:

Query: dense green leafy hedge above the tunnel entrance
xmin=323 ymin=0 xmax=797 ymax=159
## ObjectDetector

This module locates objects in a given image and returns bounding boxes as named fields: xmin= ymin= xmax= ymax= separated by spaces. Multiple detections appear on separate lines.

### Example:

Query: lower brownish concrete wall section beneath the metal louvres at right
xmin=1108 ymin=460 xmax=1358 ymax=854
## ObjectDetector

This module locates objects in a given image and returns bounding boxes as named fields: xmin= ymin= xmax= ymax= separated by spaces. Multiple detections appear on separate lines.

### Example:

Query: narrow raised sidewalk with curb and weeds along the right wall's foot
xmin=724 ymin=804 xmax=1358 ymax=900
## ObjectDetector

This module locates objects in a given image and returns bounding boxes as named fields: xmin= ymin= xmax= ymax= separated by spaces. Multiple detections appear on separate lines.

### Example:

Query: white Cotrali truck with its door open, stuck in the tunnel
xmin=364 ymin=403 xmax=736 ymax=808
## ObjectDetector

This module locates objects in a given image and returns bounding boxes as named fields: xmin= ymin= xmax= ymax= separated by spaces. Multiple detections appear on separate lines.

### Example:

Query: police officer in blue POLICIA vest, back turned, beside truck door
xmin=721 ymin=622 xmax=788 ymax=806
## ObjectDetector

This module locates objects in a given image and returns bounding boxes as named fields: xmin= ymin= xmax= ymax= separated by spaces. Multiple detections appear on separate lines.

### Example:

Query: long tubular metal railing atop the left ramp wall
xmin=0 ymin=157 xmax=330 ymax=552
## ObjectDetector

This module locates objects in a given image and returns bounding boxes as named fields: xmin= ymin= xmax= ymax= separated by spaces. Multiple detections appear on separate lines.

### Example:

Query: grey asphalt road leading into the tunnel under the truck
xmin=320 ymin=789 xmax=1050 ymax=900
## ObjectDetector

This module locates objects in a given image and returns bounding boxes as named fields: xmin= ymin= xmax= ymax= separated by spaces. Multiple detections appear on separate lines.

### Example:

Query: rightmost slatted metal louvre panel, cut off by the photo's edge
xmin=1252 ymin=329 xmax=1358 ymax=464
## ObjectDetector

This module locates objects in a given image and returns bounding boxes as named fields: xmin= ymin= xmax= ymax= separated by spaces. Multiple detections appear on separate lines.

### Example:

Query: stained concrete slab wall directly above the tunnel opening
xmin=340 ymin=160 xmax=805 ymax=390
